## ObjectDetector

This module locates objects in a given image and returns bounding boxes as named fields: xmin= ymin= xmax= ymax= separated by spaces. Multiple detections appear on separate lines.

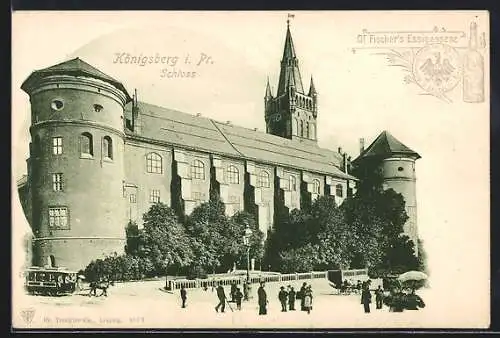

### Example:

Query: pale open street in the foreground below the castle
xmin=14 ymin=279 xmax=452 ymax=329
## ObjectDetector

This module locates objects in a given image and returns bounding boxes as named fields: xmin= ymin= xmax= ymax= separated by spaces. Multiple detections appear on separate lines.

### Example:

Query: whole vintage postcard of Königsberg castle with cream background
xmin=11 ymin=11 xmax=490 ymax=330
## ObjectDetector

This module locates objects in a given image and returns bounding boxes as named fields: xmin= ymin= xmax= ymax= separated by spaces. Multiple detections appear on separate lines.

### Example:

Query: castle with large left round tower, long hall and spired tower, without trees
xmin=18 ymin=22 xmax=356 ymax=269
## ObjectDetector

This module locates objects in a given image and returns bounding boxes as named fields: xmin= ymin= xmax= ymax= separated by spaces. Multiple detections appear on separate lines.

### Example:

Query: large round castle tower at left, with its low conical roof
xmin=21 ymin=58 xmax=131 ymax=270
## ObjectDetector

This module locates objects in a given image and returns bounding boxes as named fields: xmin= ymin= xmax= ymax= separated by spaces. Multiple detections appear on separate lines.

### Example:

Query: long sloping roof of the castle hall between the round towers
xmin=126 ymin=102 xmax=356 ymax=180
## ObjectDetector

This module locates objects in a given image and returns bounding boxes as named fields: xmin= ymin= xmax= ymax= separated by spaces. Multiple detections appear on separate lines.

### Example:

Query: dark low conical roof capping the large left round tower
xmin=21 ymin=57 xmax=132 ymax=102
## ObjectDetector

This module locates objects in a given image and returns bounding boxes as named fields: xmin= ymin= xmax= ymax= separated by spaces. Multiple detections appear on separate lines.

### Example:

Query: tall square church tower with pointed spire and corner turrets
xmin=264 ymin=21 xmax=318 ymax=143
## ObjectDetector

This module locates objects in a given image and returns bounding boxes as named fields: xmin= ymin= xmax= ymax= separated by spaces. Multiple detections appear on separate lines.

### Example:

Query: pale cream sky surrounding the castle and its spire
xmin=12 ymin=11 xmax=489 ymax=328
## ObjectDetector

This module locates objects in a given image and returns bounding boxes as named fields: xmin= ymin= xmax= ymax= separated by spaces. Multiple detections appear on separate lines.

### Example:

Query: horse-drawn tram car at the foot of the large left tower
xmin=24 ymin=266 xmax=77 ymax=296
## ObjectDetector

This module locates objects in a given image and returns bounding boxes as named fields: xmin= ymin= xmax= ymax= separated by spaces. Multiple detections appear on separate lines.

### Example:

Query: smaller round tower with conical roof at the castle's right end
xmin=356 ymin=131 xmax=421 ymax=255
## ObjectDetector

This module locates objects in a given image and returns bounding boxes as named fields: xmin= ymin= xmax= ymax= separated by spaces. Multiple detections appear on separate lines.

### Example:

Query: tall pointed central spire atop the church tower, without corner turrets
xmin=276 ymin=20 xmax=304 ymax=96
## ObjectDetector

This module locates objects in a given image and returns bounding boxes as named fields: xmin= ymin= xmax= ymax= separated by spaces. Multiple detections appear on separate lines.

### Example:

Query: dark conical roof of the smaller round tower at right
xmin=354 ymin=130 xmax=420 ymax=162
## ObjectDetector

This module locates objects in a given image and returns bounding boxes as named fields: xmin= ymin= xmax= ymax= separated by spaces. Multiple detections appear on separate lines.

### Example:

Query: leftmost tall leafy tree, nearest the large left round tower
xmin=139 ymin=203 xmax=193 ymax=274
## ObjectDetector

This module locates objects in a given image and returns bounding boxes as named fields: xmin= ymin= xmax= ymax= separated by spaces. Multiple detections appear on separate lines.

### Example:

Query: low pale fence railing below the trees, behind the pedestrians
xmin=167 ymin=271 xmax=327 ymax=290
